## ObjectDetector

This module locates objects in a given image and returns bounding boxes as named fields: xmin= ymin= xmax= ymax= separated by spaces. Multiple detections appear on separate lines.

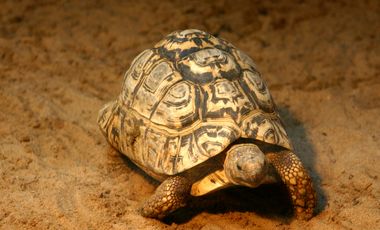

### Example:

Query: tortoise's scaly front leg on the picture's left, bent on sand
xmin=138 ymin=176 xmax=191 ymax=219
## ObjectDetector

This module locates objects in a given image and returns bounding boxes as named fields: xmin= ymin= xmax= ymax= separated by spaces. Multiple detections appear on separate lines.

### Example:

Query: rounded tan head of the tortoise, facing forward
xmin=224 ymin=143 xmax=269 ymax=188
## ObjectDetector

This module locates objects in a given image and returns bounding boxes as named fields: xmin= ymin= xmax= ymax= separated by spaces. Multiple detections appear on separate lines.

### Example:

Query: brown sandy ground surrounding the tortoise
xmin=0 ymin=0 xmax=380 ymax=230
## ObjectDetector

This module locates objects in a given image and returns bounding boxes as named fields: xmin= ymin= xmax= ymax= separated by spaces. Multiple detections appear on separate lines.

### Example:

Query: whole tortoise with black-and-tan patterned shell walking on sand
xmin=98 ymin=29 xmax=316 ymax=220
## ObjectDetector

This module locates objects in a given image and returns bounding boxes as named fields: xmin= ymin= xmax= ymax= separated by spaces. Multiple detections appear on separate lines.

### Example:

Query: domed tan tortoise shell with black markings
xmin=99 ymin=29 xmax=291 ymax=178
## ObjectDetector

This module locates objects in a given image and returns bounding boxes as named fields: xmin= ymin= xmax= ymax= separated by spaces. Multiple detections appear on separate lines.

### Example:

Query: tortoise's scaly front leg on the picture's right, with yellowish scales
xmin=267 ymin=150 xmax=316 ymax=220
